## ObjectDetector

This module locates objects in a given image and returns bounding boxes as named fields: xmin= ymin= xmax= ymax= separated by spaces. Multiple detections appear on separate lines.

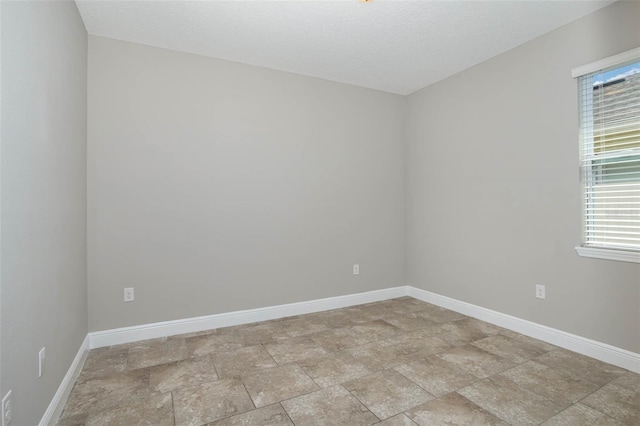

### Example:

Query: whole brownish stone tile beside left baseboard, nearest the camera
xmin=64 ymin=369 xmax=149 ymax=417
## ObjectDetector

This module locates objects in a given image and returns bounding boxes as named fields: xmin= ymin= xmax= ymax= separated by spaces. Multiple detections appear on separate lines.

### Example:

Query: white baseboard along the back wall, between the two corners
xmin=88 ymin=286 xmax=407 ymax=349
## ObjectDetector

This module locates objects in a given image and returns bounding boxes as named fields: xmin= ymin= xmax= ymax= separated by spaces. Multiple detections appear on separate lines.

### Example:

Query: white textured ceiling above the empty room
xmin=76 ymin=0 xmax=613 ymax=95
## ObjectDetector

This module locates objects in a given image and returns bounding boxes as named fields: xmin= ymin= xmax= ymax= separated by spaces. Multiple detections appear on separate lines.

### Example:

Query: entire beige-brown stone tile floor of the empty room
xmin=58 ymin=297 xmax=640 ymax=426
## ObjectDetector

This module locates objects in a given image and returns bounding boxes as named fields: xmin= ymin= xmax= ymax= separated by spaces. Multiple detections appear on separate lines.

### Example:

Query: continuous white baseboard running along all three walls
xmin=46 ymin=286 xmax=640 ymax=426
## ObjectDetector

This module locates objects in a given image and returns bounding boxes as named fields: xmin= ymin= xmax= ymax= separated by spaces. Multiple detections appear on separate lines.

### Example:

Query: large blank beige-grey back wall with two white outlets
xmin=88 ymin=36 xmax=405 ymax=330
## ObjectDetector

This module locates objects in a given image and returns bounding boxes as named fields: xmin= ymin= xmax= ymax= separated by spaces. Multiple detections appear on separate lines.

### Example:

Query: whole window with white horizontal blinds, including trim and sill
xmin=573 ymin=49 xmax=640 ymax=262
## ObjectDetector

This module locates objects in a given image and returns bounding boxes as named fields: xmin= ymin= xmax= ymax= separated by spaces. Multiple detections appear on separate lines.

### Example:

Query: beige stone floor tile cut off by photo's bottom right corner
xmin=581 ymin=384 xmax=640 ymax=425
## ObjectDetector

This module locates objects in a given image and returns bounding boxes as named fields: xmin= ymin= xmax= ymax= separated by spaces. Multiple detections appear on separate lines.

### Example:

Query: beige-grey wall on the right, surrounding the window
xmin=405 ymin=2 xmax=640 ymax=352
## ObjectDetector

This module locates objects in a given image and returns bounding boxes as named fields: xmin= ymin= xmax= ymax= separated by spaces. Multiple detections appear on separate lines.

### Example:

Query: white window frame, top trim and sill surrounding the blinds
xmin=571 ymin=47 xmax=640 ymax=263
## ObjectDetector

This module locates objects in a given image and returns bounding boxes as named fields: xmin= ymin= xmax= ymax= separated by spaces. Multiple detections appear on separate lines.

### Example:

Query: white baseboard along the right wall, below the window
xmin=407 ymin=286 xmax=640 ymax=373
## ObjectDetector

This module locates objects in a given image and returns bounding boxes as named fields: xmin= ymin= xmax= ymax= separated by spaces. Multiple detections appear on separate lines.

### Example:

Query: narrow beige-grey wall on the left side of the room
xmin=0 ymin=1 xmax=87 ymax=425
